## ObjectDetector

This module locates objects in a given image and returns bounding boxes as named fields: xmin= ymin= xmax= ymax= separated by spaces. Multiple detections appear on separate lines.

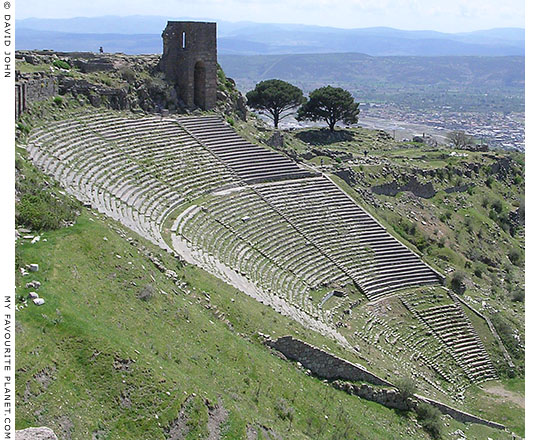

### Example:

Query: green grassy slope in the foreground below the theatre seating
xmin=16 ymin=145 xmax=508 ymax=439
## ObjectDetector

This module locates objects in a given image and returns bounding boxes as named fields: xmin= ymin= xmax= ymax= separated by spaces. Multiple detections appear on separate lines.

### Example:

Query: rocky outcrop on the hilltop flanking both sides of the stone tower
xmin=15 ymin=51 xmax=248 ymax=117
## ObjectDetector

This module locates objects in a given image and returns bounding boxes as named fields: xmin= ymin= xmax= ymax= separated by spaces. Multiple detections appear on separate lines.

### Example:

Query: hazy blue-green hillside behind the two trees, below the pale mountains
xmin=219 ymin=53 xmax=525 ymax=113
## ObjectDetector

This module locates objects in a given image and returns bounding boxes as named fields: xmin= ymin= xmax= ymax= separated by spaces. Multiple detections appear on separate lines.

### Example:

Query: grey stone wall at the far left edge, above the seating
xmin=15 ymin=73 xmax=58 ymax=119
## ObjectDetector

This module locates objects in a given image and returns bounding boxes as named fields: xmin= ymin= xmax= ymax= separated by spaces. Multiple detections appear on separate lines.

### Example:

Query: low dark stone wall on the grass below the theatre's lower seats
xmin=267 ymin=336 xmax=392 ymax=386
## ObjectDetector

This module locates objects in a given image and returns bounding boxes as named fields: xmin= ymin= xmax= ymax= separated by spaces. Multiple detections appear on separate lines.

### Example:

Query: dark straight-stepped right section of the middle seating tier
xmin=256 ymin=178 xmax=439 ymax=299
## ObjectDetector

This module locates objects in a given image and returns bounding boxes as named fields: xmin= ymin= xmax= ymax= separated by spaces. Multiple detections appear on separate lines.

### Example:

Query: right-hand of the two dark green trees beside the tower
xmin=296 ymin=86 xmax=359 ymax=131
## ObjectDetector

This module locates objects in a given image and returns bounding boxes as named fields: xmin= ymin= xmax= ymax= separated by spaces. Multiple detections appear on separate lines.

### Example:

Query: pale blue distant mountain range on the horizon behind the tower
xmin=16 ymin=16 xmax=525 ymax=56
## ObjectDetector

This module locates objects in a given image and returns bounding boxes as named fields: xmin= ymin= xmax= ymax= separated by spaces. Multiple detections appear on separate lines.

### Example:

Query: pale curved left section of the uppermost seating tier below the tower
xmin=29 ymin=111 xmax=245 ymax=254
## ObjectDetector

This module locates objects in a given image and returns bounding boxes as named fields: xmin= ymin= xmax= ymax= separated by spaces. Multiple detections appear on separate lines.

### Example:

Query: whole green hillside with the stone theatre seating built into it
xmin=16 ymin=52 xmax=524 ymax=439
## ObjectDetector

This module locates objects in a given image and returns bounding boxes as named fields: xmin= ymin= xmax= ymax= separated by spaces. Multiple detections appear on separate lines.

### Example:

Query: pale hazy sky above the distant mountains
xmin=16 ymin=0 xmax=525 ymax=32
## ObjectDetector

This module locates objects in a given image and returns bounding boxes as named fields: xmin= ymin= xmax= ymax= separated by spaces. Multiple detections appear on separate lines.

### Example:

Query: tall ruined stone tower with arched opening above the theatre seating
xmin=160 ymin=21 xmax=217 ymax=110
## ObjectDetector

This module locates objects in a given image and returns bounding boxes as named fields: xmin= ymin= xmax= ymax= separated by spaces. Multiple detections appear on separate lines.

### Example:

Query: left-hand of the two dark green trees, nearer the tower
xmin=246 ymin=79 xmax=306 ymax=128
